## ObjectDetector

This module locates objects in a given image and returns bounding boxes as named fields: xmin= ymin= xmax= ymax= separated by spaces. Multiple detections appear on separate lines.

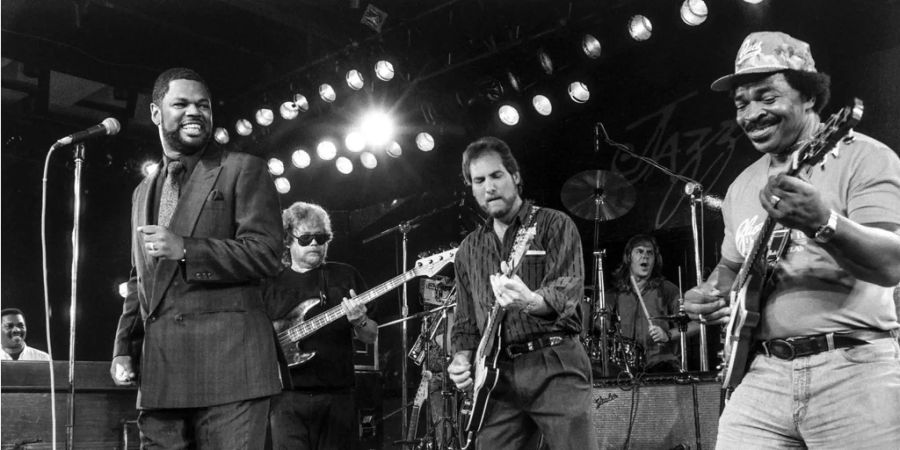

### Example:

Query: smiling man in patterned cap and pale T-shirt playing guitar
xmin=685 ymin=32 xmax=900 ymax=448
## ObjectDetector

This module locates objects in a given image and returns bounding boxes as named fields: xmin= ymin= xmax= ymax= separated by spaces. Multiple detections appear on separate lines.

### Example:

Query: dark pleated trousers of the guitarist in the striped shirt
xmin=476 ymin=338 xmax=597 ymax=450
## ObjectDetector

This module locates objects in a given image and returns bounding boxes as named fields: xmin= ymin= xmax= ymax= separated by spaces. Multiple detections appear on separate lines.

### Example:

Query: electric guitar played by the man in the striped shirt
xmin=463 ymin=224 xmax=537 ymax=449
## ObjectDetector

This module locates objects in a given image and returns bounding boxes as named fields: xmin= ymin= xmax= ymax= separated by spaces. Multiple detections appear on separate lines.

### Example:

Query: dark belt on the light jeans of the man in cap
xmin=756 ymin=330 xmax=892 ymax=361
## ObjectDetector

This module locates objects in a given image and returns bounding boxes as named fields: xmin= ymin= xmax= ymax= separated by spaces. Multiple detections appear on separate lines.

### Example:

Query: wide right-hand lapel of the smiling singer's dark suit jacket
xmin=150 ymin=146 xmax=222 ymax=312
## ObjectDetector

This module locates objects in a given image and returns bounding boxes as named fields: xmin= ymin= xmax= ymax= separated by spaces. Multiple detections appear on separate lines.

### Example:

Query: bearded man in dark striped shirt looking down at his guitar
xmin=448 ymin=137 xmax=597 ymax=450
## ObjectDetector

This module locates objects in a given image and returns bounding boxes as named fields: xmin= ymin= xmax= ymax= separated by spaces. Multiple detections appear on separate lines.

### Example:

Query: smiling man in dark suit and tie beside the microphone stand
xmin=110 ymin=69 xmax=282 ymax=449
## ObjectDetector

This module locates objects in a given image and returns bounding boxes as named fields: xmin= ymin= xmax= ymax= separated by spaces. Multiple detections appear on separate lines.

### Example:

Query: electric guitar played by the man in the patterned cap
xmin=720 ymin=99 xmax=863 ymax=392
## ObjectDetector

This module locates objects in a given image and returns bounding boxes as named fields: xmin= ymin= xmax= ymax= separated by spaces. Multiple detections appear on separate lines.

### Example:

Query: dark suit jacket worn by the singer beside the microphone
xmin=113 ymin=144 xmax=283 ymax=408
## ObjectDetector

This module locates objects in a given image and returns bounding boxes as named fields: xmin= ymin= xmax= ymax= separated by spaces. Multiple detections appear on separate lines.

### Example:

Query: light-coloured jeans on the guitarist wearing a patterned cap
xmin=716 ymin=338 xmax=900 ymax=450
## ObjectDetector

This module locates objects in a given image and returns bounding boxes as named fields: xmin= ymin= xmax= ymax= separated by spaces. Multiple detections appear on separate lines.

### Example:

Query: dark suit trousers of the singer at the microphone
xmin=138 ymin=397 xmax=269 ymax=450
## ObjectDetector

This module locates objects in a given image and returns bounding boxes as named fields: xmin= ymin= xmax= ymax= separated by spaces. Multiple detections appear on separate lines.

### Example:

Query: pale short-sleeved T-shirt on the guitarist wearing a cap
xmin=722 ymin=133 xmax=900 ymax=339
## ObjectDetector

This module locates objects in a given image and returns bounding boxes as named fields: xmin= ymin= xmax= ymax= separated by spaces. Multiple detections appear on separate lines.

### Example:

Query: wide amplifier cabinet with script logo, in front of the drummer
xmin=592 ymin=379 xmax=722 ymax=449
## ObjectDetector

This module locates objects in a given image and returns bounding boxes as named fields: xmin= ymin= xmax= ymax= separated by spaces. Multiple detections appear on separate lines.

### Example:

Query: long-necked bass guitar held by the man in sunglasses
xmin=278 ymin=248 xmax=456 ymax=367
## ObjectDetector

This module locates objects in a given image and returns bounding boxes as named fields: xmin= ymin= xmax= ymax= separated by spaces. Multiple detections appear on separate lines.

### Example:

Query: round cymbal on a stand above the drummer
xmin=560 ymin=170 xmax=635 ymax=222
